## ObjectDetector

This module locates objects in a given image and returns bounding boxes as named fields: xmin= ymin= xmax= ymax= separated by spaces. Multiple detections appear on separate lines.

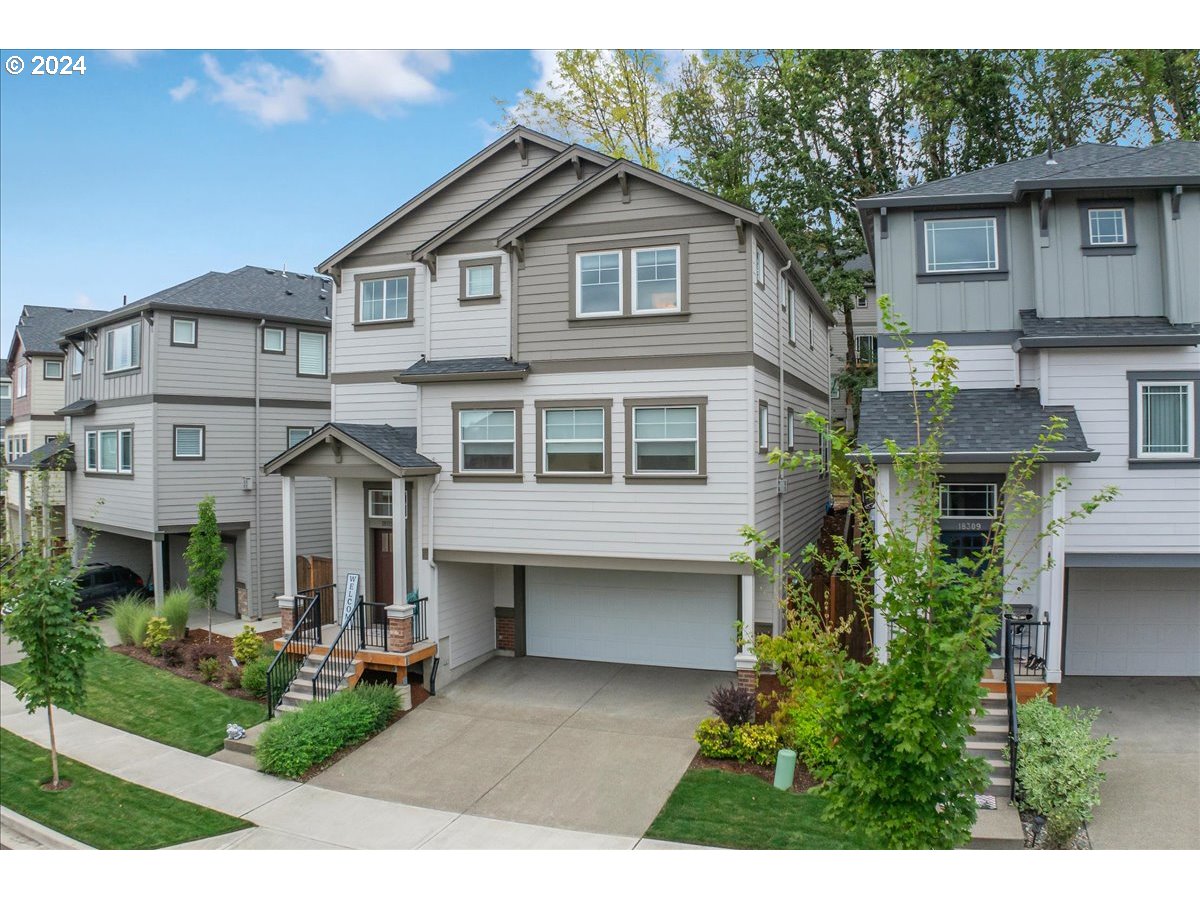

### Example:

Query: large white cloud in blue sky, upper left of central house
xmin=196 ymin=50 xmax=450 ymax=125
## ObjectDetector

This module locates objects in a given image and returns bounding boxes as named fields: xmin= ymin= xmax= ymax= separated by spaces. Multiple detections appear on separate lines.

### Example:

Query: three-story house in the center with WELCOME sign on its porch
xmin=266 ymin=128 xmax=834 ymax=679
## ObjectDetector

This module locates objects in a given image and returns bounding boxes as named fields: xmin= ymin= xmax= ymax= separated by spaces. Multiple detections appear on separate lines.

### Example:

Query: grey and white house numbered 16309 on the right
xmin=858 ymin=142 xmax=1200 ymax=683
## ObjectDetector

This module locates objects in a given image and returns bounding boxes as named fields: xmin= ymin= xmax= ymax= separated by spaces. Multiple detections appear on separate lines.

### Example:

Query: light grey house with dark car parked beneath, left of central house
xmin=59 ymin=266 xmax=331 ymax=618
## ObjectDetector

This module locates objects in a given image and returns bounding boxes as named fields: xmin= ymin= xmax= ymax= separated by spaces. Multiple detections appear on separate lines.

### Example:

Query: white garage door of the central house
xmin=526 ymin=566 xmax=737 ymax=671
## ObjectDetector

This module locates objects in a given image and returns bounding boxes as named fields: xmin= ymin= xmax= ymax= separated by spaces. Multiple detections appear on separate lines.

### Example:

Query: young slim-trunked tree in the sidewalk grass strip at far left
xmin=0 ymin=536 xmax=104 ymax=790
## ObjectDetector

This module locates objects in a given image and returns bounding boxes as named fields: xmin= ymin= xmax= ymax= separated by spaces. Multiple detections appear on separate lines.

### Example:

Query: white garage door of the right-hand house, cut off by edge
xmin=1063 ymin=568 xmax=1200 ymax=676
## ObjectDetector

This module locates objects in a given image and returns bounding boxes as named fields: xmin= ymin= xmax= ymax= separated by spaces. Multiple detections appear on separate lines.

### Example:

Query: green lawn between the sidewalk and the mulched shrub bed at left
xmin=0 ymin=650 xmax=266 ymax=756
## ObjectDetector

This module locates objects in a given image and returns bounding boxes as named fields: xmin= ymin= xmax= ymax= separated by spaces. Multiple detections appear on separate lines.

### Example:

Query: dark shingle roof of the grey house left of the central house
xmin=65 ymin=265 xmax=330 ymax=335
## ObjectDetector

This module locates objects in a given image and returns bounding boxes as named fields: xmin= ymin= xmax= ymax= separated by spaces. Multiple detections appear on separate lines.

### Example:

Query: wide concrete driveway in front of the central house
xmin=312 ymin=658 xmax=733 ymax=836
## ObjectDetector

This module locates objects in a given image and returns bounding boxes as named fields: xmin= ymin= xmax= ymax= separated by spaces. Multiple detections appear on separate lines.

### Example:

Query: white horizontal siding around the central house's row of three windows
xmin=422 ymin=366 xmax=754 ymax=563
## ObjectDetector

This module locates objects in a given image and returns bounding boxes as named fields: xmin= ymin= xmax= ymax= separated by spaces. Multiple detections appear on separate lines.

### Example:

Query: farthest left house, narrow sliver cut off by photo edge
xmin=4 ymin=306 xmax=100 ymax=544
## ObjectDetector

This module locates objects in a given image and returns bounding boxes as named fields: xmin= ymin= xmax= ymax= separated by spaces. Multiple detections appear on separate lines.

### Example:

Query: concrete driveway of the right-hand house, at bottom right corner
xmin=1058 ymin=676 xmax=1200 ymax=850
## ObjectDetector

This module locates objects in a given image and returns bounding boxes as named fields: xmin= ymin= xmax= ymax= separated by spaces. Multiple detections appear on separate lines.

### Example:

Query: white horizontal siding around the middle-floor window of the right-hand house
xmin=1042 ymin=347 xmax=1200 ymax=553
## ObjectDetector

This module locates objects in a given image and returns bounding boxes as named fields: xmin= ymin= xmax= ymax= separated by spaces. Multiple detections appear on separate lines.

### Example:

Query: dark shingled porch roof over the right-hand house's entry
xmin=858 ymin=388 xmax=1097 ymax=461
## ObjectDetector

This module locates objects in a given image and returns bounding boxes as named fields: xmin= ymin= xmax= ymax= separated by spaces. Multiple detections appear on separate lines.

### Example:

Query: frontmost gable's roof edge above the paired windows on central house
xmin=496 ymin=160 xmax=838 ymax=325
